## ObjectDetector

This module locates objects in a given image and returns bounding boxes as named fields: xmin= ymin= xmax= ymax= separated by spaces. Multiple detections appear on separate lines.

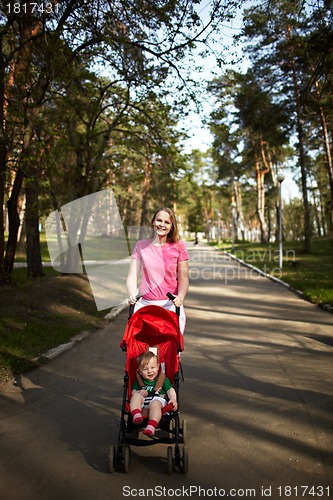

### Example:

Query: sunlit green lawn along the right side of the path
xmin=214 ymin=238 xmax=333 ymax=306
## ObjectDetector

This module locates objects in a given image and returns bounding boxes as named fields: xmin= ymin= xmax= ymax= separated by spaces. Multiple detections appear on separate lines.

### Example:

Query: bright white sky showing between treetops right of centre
xmin=181 ymin=0 xmax=300 ymax=200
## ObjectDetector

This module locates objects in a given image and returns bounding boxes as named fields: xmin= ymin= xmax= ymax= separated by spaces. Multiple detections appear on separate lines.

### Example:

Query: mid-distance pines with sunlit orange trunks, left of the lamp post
xmin=211 ymin=70 xmax=288 ymax=242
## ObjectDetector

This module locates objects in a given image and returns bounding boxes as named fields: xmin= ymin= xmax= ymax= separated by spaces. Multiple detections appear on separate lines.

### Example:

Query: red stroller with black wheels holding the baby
xmin=109 ymin=294 xmax=188 ymax=474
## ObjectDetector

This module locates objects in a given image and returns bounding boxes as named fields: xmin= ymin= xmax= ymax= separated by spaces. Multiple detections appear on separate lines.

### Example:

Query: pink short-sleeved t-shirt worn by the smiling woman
xmin=132 ymin=240 xmax=188 ymax=300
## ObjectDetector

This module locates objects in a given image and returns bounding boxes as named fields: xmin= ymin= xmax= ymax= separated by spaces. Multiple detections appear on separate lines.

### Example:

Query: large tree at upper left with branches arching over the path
xmin=0 ymin=0 xmax=244 ymax=279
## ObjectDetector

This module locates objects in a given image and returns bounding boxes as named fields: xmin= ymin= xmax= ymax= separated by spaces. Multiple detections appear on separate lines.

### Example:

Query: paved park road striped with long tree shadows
xmin=0 ymin=247 xmax=333 ymax=500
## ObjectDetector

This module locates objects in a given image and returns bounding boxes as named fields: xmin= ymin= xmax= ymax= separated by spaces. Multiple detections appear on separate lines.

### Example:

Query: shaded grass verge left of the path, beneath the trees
xmin=0 ymin=268 xmax=106 ymax=386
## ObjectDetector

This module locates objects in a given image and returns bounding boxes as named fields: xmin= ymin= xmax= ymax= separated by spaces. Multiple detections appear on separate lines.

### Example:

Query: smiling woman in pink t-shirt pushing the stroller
xmin=126 ymin=207 xmax=189 ymax=333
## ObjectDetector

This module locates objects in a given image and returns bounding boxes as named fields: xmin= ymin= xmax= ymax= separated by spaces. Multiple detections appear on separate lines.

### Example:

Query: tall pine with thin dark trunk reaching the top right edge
xmin=240 ymin=0 xmax=328 ymax=251
